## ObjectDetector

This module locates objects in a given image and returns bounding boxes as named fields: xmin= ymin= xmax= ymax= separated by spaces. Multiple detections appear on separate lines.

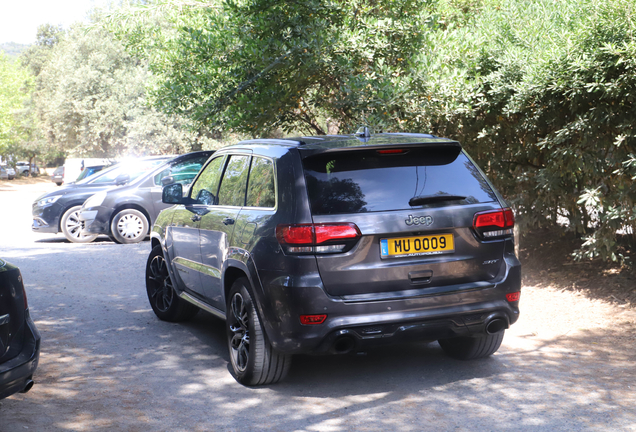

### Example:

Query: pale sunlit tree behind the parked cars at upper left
xmin=33 ymin=16 xmax=211 ymax=157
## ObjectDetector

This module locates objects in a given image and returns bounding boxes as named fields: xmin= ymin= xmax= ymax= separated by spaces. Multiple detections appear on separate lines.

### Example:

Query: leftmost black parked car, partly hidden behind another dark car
xmin=31 ymin=156 xmax=174 ymax=243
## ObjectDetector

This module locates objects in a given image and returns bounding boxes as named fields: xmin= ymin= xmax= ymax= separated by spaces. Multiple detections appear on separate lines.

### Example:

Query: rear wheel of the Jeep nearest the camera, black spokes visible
xmin=226 ymin=278 xmax=291 ymax=386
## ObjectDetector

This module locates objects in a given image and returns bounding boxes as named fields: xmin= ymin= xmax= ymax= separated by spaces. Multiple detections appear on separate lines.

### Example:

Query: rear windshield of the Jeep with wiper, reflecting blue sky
xmin=303 ymin=147 xmax=497 ymax=215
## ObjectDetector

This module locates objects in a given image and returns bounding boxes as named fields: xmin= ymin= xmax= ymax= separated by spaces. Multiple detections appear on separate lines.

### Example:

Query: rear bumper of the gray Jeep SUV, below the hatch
xmin=259 ymin=251 xmax=521 ymax=353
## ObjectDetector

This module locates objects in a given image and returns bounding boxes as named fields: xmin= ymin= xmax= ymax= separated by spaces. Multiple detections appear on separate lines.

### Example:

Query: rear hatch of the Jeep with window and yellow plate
xmin=301 ymin=143 xmax=508 ymax=300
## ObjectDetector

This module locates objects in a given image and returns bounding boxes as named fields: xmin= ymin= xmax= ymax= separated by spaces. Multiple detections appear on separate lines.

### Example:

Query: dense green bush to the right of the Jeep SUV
xmin=413 ymin=0 xmax=636 ymax=260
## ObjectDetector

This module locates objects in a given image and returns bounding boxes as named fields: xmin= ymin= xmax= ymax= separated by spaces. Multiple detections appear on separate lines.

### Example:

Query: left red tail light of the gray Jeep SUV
xmin=276 ymin=223 xmax=362 ymax=254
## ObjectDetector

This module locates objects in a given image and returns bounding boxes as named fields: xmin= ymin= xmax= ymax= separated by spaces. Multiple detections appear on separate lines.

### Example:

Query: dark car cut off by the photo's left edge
xmin=0 ymin=259 xmax=40 ymax=399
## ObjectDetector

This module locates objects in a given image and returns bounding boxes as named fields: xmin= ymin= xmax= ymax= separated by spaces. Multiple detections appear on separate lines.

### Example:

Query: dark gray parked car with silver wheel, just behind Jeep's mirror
xmin=78 ymin=151 xmax=214 ymax=243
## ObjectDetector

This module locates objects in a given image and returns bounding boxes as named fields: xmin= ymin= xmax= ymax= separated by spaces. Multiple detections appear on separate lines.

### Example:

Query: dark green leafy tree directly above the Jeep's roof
xmin=111 ymin=0 xmax=425 ymax=135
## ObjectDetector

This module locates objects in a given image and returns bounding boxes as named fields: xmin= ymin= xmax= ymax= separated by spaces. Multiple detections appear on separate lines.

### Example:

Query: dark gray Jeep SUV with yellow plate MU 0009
xmin=146 ymin=133 xmax=521 ymax=385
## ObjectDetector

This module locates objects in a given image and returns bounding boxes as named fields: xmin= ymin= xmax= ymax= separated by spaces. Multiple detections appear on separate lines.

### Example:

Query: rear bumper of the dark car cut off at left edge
xmin=0 ymin=312 xmax=40 ymax=399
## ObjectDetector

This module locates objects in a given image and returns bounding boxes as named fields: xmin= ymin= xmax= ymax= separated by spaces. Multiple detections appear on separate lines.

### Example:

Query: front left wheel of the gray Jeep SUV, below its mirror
xmin=146 ymin=246 xmax=199 ymax=322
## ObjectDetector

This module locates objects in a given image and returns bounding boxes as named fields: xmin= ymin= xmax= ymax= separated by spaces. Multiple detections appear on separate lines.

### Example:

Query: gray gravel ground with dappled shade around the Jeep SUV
xmin=0 ymin=180 xmax=636 ymax=432
